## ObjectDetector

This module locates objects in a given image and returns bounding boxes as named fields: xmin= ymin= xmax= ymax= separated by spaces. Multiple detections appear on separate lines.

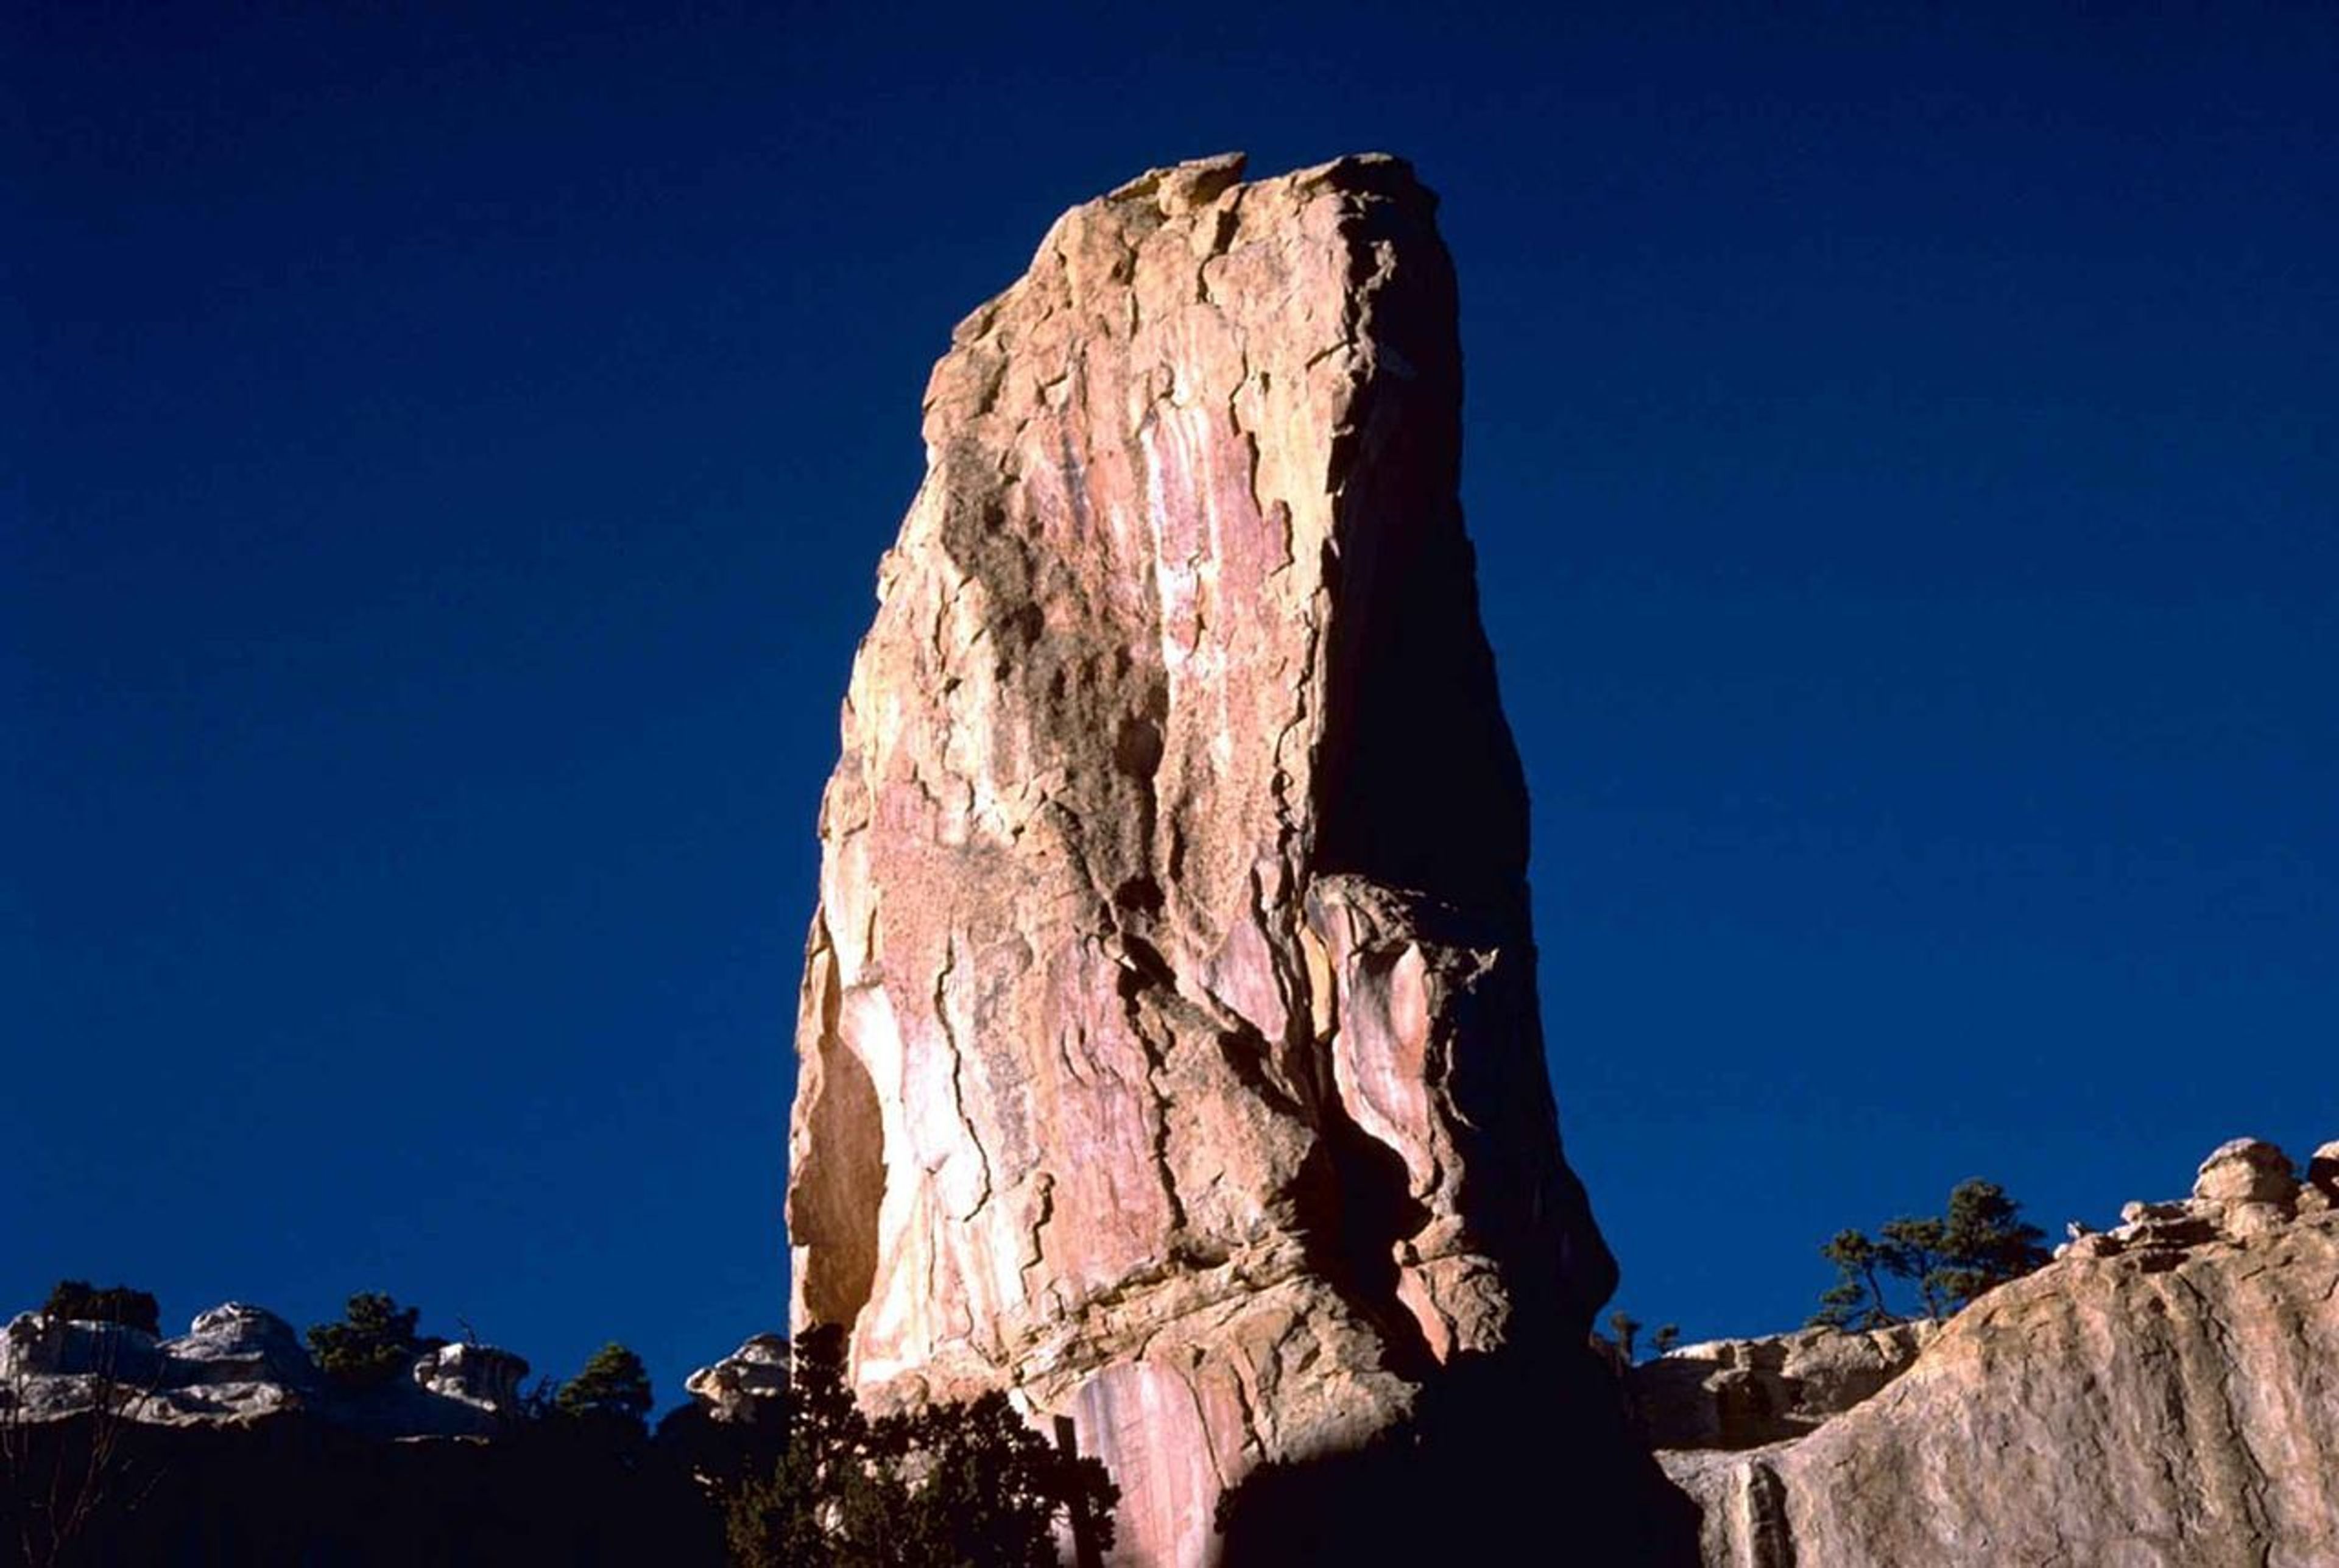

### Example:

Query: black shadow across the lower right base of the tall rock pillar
xmin=1219 ymin=1353 xmax=1698 ymax=1568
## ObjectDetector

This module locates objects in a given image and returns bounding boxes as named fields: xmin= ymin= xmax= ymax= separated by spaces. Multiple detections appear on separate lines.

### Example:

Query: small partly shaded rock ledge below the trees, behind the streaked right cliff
xmin=1626 ymin=1323 xmax=1939 ymax=1449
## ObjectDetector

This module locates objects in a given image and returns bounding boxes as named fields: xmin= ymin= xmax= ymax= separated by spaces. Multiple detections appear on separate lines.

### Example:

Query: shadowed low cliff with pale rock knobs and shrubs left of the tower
xmin=0 ymin=1301 xmax=758 ymax=1568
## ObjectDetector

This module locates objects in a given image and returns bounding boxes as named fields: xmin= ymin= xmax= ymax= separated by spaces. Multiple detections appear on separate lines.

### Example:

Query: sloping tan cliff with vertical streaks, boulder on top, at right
xmin=1660 ymin=1140 xmax=2339 ymax=1568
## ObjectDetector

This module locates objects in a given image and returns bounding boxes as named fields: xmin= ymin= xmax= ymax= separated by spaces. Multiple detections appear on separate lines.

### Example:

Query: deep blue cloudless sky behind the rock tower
xmin=0 ymin=2 xmax=2339 ymax=1397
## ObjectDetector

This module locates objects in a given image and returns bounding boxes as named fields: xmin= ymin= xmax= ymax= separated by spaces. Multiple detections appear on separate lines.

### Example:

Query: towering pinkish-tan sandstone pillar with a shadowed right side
xmin=788 ymin=157 xmax=1646 ymax=1563
